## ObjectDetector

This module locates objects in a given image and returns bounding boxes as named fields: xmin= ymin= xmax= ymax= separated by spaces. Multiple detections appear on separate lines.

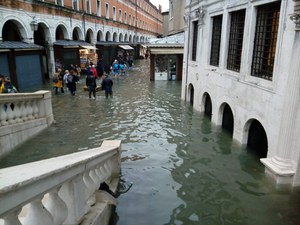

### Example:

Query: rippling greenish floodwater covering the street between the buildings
xmin=0 ymin=61 xmax=300 ymax=225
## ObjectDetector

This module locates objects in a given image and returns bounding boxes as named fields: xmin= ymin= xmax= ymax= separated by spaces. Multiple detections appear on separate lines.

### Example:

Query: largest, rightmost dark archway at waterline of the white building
xmin=247 ymin=120 xmax=268 ymax=158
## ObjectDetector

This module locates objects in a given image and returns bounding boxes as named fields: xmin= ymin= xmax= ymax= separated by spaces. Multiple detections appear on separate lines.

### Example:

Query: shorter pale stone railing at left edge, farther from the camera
xmin=0 ymin=91 xmax=54 ymax=156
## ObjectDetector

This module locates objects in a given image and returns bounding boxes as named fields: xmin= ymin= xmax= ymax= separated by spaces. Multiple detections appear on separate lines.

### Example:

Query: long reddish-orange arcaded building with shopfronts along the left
xmin=0 ymin=0 xmax=163 ymax=91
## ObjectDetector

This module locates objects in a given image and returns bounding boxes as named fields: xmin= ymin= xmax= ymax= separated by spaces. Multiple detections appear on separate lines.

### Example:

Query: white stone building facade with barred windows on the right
xmin=181 ymin=0 xmax=300 ymax=189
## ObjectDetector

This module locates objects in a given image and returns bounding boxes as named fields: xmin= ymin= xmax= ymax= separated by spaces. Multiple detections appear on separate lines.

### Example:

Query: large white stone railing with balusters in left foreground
xmin=0 ymin=141 xmax=121 ymax=225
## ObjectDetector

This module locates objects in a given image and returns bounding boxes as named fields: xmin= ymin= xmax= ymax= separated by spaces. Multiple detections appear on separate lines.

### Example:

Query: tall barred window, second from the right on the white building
xmin=227 ymin=10 xmax=246 ymax=72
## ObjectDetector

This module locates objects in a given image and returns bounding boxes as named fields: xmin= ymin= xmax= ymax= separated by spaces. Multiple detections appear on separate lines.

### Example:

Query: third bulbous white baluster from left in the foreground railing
xmin=44 ymin=188 xmax=68 ymax=225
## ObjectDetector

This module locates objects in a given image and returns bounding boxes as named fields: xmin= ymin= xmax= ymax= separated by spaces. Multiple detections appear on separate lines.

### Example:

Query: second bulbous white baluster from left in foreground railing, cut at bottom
xmin=23 ymin=197 xmax=54 ymax=225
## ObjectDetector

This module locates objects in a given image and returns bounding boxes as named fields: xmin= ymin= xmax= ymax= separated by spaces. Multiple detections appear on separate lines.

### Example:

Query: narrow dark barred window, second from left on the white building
xmin=210 ymin=15 xmax=223 ymax=66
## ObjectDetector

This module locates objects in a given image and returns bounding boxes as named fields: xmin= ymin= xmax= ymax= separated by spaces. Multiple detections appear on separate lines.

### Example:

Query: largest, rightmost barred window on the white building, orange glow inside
xmin=251 ymin=2 xmax=280 ymax=80
